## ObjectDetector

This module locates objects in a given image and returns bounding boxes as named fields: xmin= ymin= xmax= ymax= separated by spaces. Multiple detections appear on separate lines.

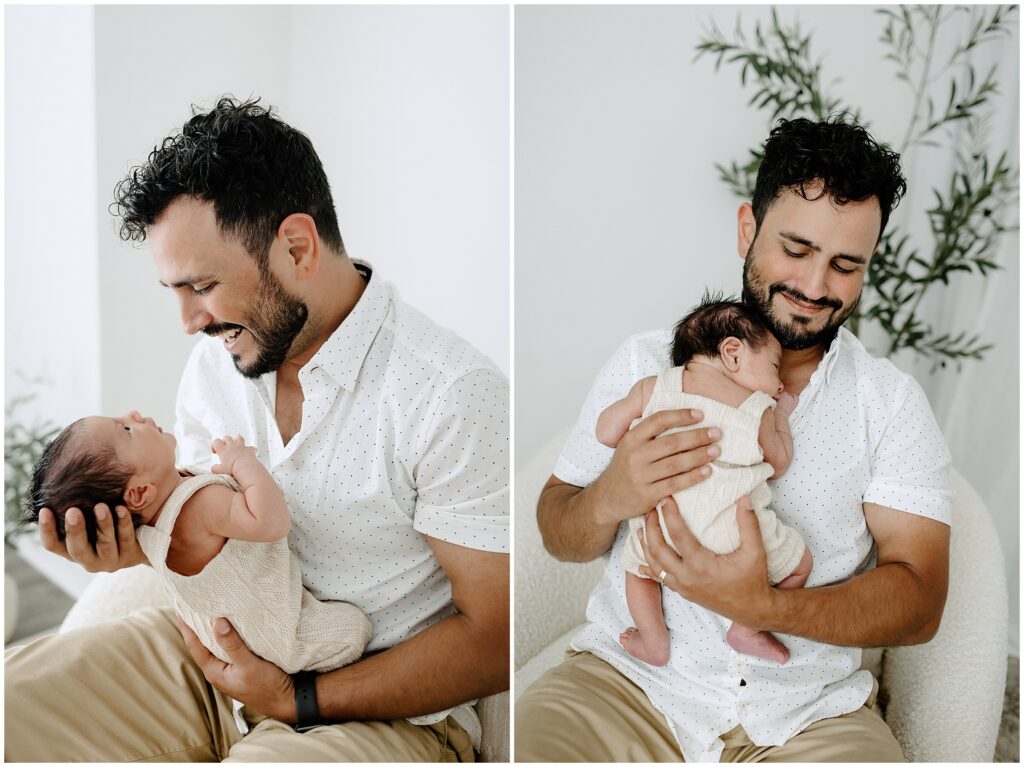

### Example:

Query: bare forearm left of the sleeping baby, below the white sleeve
xmin=537 ymin=478 xmax=618 ymax=562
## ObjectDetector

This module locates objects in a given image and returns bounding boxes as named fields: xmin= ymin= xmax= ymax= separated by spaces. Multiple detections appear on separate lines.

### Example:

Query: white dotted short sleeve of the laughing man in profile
xmin=413 ymin=369 xmax=509 ymax=552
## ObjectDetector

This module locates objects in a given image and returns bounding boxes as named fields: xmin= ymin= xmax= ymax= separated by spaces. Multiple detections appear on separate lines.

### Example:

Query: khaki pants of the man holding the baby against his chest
xmin=515 ymin=652 xmax=905 ymax=762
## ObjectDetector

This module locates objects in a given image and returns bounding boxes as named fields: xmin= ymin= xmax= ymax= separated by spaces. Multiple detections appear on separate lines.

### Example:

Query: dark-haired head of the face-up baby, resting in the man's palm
xmin=24 ymin=411 xmax=178 ymax=546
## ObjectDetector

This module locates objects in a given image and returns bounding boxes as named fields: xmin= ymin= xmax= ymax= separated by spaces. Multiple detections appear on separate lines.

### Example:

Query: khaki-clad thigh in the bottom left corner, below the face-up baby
xmin=4 ymin=608 xmax=240 ymax=762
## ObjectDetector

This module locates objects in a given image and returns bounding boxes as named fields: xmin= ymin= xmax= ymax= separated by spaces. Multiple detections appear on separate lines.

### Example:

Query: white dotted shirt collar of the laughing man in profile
xmin=300 ymin=259 xmax=391 ymax=391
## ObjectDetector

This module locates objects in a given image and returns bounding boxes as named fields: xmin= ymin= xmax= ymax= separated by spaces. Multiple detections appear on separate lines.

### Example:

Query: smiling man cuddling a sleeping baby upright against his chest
xmin=516 ymin=120 xmax=951 ymax=762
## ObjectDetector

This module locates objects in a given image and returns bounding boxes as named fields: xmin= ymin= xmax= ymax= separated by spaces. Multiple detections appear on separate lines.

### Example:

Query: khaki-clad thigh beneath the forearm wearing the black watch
xmin=224 ymin=717 xmax=474 ymax=762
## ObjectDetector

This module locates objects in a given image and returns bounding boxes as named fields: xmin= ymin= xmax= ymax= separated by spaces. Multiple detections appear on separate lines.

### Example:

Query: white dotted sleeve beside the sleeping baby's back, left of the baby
xmin=553 ymin=330 xmax=671 ymax=487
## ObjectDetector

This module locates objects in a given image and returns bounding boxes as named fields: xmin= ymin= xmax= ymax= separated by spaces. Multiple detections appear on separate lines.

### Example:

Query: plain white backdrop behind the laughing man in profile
xmin=4 ymin=5 xmax=510 ymax=436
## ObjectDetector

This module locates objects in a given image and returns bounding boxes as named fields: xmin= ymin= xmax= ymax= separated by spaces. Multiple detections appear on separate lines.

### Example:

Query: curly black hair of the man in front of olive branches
xmin=751 ymin=115 xmax=906 ymax=239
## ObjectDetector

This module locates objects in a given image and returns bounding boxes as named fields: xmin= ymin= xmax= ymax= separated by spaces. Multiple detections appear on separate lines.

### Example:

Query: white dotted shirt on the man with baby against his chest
xmin=554 ymin=329 xmax=952 ymax=762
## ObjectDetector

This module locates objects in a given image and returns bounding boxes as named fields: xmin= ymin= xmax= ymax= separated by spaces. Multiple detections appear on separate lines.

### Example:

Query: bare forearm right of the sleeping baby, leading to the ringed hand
xmin=758 ymin=563 xmax=945 ymax=647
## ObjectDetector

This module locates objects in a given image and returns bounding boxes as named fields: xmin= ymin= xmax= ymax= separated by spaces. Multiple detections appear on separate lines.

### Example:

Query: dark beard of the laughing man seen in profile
xmin=203 ymin=272 xmax=309 ymax=378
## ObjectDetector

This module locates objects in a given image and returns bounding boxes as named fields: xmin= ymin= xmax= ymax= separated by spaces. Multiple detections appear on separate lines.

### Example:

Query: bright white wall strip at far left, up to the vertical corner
xmin=4 ymin=6 xmax=100 ymax=424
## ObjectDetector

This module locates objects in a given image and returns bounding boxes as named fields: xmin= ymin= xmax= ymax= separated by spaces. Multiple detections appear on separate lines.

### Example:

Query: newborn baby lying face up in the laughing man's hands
xmin=26 ymin=412 xmax=371 ymax=674
